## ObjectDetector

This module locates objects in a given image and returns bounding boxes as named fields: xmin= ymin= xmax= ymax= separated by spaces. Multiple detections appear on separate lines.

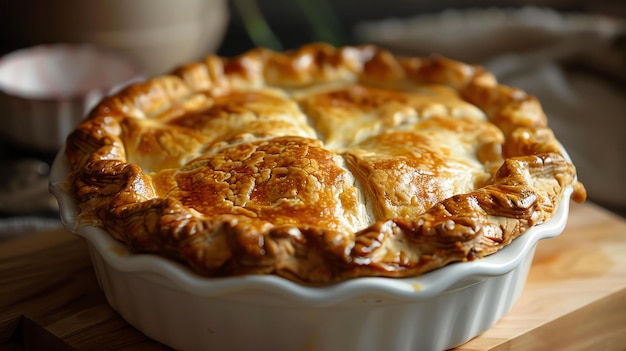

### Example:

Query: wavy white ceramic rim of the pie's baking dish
xmin=50 ymin=149 xmax=574 ymax=305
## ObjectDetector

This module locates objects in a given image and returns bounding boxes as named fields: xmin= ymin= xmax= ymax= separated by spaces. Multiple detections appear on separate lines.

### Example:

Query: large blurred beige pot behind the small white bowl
xmin=9 ymin=0 xmax=228 ymax=76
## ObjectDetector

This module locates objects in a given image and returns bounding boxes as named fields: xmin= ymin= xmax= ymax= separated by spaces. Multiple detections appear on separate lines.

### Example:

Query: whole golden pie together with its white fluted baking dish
xmin=51 ymin=44 xmax=585 ymax=350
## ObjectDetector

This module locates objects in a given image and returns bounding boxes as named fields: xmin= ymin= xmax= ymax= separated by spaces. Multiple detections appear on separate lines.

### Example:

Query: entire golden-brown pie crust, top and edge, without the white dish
xmin=65 ymin=44 xmax=585 ymax=284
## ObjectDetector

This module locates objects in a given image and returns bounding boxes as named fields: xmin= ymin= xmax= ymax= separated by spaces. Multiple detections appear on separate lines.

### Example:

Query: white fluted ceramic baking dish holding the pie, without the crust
xmin=50 ymin=148 xmax=572 ymax=351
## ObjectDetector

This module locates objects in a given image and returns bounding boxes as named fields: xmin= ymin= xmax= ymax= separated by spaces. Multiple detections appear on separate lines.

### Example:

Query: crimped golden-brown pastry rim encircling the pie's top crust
xmin=61 ymin=45 xmax=584 ymax=284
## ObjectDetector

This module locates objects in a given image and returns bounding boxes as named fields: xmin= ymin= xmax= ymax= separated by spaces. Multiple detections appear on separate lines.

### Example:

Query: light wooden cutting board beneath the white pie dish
xmin=0 ymin=203 xmax=626 ymax=351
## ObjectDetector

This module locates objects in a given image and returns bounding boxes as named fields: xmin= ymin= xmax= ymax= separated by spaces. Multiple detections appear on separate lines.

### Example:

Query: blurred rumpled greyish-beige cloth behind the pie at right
xmin=355 ymin=7 xmax=626 ymax=208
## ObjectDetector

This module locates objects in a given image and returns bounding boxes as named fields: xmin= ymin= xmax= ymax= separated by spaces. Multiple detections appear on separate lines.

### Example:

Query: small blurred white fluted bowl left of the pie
xmin=0 ymin=44 xmax=140 ymax=152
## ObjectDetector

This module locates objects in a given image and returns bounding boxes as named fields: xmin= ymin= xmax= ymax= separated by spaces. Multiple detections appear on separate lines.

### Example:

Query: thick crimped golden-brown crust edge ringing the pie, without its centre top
xmin=66 ymin=44 xmax=586 ymax=283
